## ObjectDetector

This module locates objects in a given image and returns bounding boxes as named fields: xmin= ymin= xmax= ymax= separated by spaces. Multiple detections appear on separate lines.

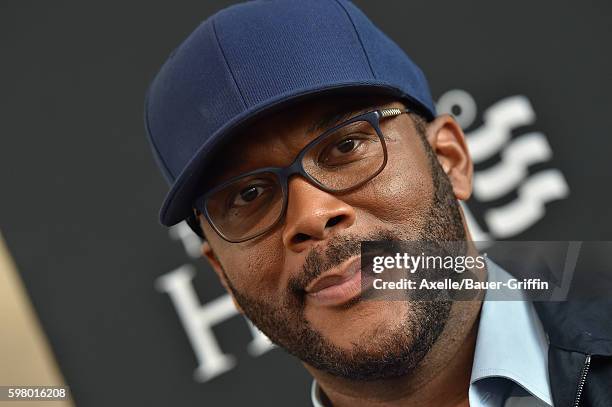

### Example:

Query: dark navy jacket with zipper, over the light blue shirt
xmin=502 ymin=241 xmax=612 ymax=407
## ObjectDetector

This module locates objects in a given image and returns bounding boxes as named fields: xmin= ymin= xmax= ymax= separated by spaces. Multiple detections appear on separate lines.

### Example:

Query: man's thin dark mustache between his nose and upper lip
xmin=288 ymin=230 xmax=401 ymax=295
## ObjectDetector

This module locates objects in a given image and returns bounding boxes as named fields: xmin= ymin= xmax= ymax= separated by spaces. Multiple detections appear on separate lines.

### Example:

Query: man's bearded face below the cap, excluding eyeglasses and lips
xmin=201 ymin=97 xmax=466 ymax=380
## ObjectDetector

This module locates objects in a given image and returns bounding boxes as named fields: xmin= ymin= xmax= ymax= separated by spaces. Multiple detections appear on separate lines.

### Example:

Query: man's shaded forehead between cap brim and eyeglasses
xmin=206 ymin=94 xmax=395 ymax=186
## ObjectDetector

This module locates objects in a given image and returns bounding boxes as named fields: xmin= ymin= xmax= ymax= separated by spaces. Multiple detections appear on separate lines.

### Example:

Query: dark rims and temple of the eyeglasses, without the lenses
xmin=191 ymin=108 xmax=412 ymax=243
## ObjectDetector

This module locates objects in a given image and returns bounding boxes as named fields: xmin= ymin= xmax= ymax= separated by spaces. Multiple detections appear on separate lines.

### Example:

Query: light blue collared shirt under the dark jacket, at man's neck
xmin=311 ymin=261 xmax=553 ymax=407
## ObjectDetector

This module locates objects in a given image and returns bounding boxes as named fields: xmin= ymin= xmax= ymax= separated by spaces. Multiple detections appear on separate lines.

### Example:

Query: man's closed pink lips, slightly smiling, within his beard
xmin=305 ymin=256 xmax=372 ymax=306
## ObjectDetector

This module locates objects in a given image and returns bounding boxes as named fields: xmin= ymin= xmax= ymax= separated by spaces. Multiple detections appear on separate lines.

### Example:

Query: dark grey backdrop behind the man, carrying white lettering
xmin=0 ymin=0 xmax=612 ymax=406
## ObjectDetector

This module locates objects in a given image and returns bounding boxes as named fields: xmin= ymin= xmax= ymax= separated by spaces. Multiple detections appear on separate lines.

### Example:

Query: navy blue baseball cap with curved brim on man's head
xmin=145 ymin=0 xmax=436 ymax=226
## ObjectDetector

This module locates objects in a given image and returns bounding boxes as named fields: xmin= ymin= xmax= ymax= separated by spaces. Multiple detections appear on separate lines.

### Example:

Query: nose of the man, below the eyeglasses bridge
xmin=282 ymin=176 xmax=355 ymax=252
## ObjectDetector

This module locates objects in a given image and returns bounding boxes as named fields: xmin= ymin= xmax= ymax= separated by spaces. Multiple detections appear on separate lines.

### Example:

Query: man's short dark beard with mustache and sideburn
xmin=220 ymin=139 xmax=466 ymax=381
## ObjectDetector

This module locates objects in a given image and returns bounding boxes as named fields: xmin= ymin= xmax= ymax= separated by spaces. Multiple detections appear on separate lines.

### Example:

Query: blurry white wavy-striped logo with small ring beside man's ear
xmin=437 ymin=90 xmax=569 ymax=241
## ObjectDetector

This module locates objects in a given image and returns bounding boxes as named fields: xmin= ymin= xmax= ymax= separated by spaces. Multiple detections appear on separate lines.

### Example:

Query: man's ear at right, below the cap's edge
xmin=427 ymin=114 xmax=474 ymax=201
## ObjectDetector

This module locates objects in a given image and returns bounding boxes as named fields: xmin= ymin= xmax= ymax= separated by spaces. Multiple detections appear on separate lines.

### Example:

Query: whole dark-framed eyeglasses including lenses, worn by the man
xmin=194 ymin=108 xmax=411 ymax=243
